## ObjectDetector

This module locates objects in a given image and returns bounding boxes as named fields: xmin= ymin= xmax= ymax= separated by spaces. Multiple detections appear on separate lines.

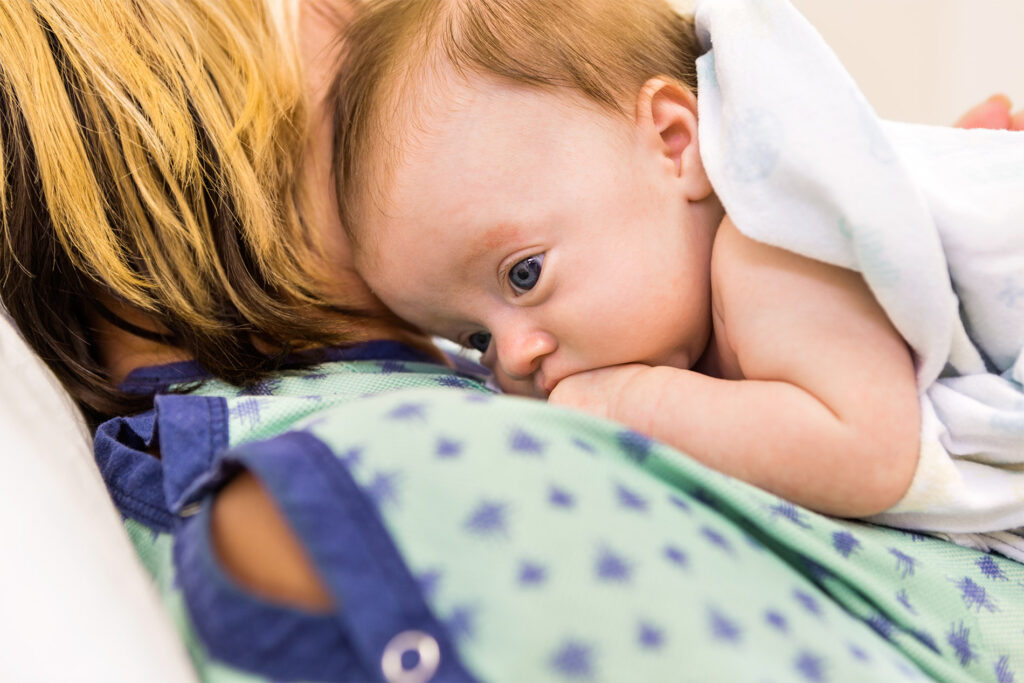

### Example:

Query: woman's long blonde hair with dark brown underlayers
xmin=0 ymin=0 xmax=362 ymax=418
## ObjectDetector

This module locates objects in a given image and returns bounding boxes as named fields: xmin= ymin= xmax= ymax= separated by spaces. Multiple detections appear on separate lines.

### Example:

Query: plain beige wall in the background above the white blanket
xmin=676 ymin=0 xmax=1024 ymax=124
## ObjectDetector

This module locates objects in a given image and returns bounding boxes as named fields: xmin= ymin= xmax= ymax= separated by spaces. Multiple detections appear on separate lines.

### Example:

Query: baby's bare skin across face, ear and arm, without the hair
xmin=356 ymin=77 xmax=920 ymax=517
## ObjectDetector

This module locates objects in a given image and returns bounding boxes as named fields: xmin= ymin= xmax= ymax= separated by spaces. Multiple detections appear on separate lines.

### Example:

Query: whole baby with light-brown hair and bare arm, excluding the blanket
xmin=335 ymin=0 xmax=1024 ymax=528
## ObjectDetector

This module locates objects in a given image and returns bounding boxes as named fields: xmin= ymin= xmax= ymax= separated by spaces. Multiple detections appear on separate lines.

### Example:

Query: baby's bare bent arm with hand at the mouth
xmin=551 ymin=218 xmax=920 ymax=517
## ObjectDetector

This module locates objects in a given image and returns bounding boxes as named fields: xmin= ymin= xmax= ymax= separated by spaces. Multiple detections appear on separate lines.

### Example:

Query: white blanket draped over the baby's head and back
xmin=695 ymin=0 xmax=1024 ymax=548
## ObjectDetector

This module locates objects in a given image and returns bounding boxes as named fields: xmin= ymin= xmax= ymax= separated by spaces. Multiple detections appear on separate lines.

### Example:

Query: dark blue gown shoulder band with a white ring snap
xmin=225 ymin=432 xmax=474 ymax=682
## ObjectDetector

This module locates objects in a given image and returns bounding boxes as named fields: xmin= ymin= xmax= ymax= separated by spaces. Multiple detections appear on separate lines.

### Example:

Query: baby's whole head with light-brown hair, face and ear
xmin=335 ymin=0 xmax=720 ymax=394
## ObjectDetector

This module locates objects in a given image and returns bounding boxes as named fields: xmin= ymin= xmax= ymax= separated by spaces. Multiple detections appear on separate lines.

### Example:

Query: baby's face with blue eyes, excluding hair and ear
xmin=356 ymin=79 xmax=714 ymax=396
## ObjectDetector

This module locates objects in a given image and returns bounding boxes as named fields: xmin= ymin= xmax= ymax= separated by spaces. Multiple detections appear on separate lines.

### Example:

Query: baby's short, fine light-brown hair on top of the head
xmin=332 ymin=0 xmax=699 ymax=244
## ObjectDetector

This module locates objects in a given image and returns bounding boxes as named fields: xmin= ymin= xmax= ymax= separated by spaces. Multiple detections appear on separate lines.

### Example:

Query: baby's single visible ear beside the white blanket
xmin=636 ymin=77 xmax=712 ymax=202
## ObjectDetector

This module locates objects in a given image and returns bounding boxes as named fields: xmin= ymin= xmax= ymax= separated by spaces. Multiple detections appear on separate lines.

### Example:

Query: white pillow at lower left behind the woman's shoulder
xmin=0 ymin=308 xmax=196 ymax=683
